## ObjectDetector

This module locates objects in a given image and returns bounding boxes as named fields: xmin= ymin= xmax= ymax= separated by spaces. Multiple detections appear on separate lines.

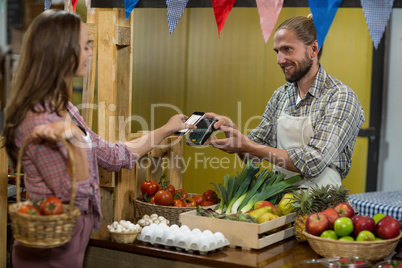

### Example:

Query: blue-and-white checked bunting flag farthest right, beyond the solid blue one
xmin=360 ymin=0 xmax=394 ymax=49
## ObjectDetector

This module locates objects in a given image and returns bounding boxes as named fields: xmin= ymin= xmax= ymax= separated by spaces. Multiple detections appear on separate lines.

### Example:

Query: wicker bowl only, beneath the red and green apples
xmin=303 ymin=230 xmax=402 ymax=261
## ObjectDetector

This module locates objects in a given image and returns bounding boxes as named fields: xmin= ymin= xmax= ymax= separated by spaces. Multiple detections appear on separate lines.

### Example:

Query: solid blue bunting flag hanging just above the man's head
xmin=308 ymin=0 xmax=342 ymax=48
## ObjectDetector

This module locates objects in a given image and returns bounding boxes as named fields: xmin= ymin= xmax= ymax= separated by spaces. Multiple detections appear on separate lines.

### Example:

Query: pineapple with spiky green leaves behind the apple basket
xmin=293 ymin=185 xmax=348 ymax=242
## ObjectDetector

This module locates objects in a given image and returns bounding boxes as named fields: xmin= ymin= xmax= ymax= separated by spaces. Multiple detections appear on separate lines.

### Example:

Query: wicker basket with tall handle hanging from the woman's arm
xmin=9 ymin=138 xmax=81 ymax=248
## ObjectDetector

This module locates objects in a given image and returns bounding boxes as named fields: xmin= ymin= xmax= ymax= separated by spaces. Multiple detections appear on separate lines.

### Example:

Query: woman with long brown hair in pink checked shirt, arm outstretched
xmin=2 ymin=10 xmax=195 ymax=267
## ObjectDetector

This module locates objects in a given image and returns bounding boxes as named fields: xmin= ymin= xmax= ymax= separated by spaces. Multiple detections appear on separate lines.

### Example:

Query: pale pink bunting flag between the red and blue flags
xmin=257 ymin=0 xmax=283 ymax=43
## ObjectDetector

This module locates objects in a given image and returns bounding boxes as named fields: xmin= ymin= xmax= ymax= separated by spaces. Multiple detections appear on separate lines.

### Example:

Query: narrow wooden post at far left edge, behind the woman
xmin=0 ymin=139 xmax=8 ymax=267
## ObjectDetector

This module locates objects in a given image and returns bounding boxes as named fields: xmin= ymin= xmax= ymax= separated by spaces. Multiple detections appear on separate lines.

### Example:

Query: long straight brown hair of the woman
xmin=2 ymin=10 xmax=81 ymax=163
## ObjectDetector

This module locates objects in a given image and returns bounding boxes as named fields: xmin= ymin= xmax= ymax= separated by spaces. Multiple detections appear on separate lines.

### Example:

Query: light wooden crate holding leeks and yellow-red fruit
xmin=180 ymin=210 xmax=296 ymax=250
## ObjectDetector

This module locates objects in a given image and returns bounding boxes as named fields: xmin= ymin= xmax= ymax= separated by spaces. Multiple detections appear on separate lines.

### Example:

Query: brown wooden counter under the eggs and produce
xmin=84 ymin=226 xmax=342 ymax=268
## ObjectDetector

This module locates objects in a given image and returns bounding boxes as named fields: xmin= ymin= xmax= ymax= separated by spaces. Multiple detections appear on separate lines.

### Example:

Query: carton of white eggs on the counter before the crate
xmin=137 ymin=224 xmax=230 ymax=254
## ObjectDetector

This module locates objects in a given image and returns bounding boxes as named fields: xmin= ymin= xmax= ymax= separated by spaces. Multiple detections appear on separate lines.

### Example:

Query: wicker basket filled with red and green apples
xmin=304 ymin=203 xmax=402 ymax=261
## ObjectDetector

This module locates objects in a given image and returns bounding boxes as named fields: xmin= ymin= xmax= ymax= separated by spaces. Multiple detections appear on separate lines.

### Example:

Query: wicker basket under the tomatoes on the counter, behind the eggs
xmin=134 ymin=194 xmax=218 ymax=226
